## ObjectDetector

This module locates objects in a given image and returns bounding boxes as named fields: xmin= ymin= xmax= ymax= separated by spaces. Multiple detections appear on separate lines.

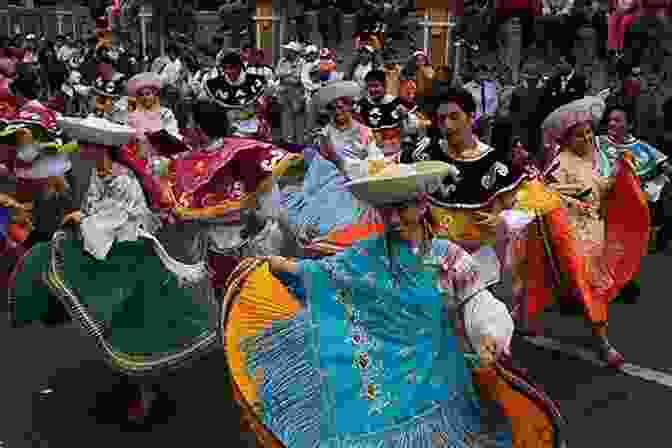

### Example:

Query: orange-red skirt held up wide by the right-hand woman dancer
xmin=512 ymin=159 xmax=650 ymax=323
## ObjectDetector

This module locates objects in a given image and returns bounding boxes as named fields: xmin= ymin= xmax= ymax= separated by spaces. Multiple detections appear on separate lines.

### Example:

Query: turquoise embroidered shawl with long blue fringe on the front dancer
xmin=243 ymin=237 xmax=511 ymax=448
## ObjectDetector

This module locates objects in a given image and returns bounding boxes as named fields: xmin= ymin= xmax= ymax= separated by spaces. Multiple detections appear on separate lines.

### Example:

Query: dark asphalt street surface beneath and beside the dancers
xmin=0 ymin=247 xmax=672 ymax=448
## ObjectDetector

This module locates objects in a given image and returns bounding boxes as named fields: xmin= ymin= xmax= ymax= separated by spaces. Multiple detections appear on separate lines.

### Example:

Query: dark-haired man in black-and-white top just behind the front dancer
xmin=401 ymin=84 xmax=535 ymax=284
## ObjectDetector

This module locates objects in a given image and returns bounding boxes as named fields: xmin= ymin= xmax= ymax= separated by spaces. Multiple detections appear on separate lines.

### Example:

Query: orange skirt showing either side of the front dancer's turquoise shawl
xmin=221 ymin=259 xmax=565 ymax=448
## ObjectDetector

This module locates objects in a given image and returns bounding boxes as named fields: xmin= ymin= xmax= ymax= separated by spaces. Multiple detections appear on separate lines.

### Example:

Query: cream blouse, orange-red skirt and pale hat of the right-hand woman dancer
xmin=511 ymin=98 xmax=650 ymax=365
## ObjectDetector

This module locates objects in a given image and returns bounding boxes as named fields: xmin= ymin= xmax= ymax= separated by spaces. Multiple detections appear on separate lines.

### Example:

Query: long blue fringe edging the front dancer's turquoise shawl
xmin=241 ymin=311 xmax=512 ymax=448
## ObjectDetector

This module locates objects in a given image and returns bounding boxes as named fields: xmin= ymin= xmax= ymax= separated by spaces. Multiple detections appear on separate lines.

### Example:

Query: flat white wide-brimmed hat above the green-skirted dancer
xmin=56 ymin=117 xmax=137 ymax=147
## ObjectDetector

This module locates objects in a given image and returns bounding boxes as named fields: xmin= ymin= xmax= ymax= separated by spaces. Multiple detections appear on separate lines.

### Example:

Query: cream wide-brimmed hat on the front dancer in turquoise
xmin=346 ymin=161 xmax=455 ymax=206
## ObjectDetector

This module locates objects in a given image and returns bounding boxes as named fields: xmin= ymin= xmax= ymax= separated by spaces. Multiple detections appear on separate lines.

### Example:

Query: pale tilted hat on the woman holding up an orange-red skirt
xmin=541 ymin=96 xmax=607 ymax=143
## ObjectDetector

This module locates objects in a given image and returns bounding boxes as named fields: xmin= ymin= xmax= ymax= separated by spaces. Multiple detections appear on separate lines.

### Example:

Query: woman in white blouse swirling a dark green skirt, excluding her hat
xmin=8 ymin=133 xmax=218 ymax=422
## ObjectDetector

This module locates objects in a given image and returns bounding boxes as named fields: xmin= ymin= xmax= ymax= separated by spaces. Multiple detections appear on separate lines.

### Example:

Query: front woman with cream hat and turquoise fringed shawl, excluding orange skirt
xmin=240 ymin=162 xmax=532 ymax=448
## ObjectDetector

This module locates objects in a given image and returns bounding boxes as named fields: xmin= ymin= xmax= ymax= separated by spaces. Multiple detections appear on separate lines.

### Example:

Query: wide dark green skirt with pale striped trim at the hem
xmin=10 ymin=232 xmax=218 ymax=374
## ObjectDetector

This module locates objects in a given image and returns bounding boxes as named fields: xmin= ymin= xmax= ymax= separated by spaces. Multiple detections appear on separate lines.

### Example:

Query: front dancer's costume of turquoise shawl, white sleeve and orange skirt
xmin=222 ymin=163 xmax=562 ymax=448
